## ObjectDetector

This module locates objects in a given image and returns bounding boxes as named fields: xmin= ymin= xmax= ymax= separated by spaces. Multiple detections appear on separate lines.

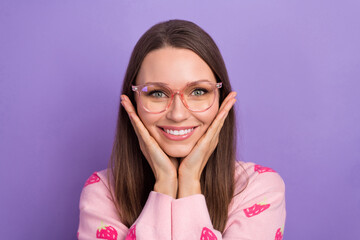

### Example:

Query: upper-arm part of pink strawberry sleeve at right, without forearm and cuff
xmin=223 ymin=165 xmax=286 ymax=240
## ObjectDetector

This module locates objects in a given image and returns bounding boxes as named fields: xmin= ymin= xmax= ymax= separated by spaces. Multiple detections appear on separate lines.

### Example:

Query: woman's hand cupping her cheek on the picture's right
xmin=178 ymin=92 xmax=236 ymax=198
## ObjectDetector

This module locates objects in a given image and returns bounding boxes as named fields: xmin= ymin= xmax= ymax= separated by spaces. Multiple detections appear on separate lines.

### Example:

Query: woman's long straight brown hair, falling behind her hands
xmin=109 ymin=20 xmax=246 ymax=232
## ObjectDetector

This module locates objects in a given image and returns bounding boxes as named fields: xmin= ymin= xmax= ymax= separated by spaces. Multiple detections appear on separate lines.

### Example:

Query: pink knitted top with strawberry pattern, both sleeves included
xmin=77 ymin=162 xmax=286 ymax=240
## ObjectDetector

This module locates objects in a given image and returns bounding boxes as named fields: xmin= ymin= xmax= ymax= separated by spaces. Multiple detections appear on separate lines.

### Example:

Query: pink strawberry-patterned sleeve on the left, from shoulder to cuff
xmin=77 ymin=171 xmax=172 ymax=240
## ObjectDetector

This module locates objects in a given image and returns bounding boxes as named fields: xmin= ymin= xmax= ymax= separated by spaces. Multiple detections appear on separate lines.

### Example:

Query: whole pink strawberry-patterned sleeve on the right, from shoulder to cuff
xmin=172 ymin=163 xmax=286 ymax=240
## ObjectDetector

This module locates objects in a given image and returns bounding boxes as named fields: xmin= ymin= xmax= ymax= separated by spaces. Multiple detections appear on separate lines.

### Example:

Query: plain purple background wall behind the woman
xmin=0 ymin=0 xmax=360 ymax=240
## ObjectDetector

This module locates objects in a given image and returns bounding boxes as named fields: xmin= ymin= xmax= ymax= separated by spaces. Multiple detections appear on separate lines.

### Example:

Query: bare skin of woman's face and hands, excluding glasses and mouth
xmin=121 ymin=47 xmax=236 ymax=198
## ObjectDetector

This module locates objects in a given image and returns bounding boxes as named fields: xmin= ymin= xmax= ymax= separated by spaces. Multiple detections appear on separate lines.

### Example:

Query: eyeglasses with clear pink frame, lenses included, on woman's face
xmin=132 ymin=80 xmax=222 ymax=113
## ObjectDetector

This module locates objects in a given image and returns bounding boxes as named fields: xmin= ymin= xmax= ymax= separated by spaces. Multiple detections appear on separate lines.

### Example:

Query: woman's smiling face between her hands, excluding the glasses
xmin=135 ymin=47 xmax=219 ymax=157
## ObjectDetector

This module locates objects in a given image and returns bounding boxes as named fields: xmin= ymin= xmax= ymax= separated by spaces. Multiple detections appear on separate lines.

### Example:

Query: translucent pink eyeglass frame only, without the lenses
xmin=131 ymin=80 xmax=222 ymax=114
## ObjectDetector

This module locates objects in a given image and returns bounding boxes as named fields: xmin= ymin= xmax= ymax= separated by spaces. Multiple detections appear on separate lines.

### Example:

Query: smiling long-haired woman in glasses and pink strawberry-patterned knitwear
xmin=78 ymin=20 xmax=285 ymax=240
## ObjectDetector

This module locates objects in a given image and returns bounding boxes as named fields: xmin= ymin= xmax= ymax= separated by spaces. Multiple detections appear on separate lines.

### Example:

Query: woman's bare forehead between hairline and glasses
xmin=135 ymin=47 xmax=216 ymax=88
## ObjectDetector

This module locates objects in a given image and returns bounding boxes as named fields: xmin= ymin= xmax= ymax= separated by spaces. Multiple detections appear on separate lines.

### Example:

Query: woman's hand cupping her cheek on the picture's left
xmin=121 ymin=95 xmax=178 ymax=198
